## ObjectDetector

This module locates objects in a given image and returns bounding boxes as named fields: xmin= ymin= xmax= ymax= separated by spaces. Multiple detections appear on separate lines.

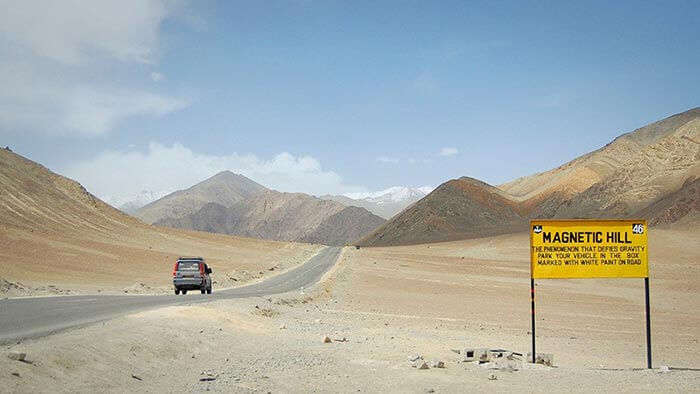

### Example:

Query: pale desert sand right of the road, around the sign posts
xmin=0 ymin=228 xmax=700 ymax=392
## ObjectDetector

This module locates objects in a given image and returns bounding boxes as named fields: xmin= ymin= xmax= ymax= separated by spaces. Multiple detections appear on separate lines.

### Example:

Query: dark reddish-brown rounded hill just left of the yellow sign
xmin=358 ymin=177 xmax=527 ymax=246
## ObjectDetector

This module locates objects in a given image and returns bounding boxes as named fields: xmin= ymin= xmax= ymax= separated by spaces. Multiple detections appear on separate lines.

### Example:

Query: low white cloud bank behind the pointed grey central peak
xmin=61 ymin=143 xmax=365 ymax=203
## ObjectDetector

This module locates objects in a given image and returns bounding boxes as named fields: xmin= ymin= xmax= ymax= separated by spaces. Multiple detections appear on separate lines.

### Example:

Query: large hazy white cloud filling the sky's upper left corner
xmin=0 ymin=0 xmax=188 ymax=136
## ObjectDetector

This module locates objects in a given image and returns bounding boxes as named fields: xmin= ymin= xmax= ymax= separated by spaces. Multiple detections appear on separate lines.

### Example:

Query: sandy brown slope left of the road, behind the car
xmin=0 ymin=149 xmax=318 ymax=295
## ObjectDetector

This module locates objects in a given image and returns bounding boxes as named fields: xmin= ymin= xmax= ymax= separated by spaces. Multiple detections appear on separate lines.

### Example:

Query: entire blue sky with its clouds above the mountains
xmin=0 ymin=0 xmax=700 ymax=206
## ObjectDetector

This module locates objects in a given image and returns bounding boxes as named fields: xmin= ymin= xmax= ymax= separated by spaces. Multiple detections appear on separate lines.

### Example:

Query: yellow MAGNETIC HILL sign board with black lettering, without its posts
xmin=530 ymin=219 xmax=649 ymax=279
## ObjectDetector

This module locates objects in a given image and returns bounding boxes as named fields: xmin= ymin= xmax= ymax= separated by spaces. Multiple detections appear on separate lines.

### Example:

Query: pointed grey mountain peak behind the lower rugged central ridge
xmin=135 ymin=171 xmax=268 ymax=223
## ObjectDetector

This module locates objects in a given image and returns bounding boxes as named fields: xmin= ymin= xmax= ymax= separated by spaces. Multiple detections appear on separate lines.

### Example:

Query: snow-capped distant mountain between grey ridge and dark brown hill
xmin=321 ymin=186 xmax=432 ymax=219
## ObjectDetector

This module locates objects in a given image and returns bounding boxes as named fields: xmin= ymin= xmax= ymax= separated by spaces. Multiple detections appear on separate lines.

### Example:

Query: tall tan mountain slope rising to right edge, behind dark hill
xmin=499 ymin=108 xmax=700 ymax=217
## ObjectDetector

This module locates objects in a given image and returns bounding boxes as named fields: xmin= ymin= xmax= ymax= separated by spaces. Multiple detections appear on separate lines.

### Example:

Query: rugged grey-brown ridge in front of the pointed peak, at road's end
xmin=156 ymin=190 xmax=384 ymax=245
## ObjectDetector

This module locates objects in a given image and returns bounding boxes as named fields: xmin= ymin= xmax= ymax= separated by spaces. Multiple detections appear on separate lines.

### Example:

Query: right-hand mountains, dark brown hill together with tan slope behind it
xmin=360 ymin=108 xmax=700 ymax=246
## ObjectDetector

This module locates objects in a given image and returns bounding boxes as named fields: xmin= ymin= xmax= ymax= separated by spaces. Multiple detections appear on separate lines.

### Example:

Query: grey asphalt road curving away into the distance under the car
xmin=0 ymin=247 xmax=341 ymax=344
